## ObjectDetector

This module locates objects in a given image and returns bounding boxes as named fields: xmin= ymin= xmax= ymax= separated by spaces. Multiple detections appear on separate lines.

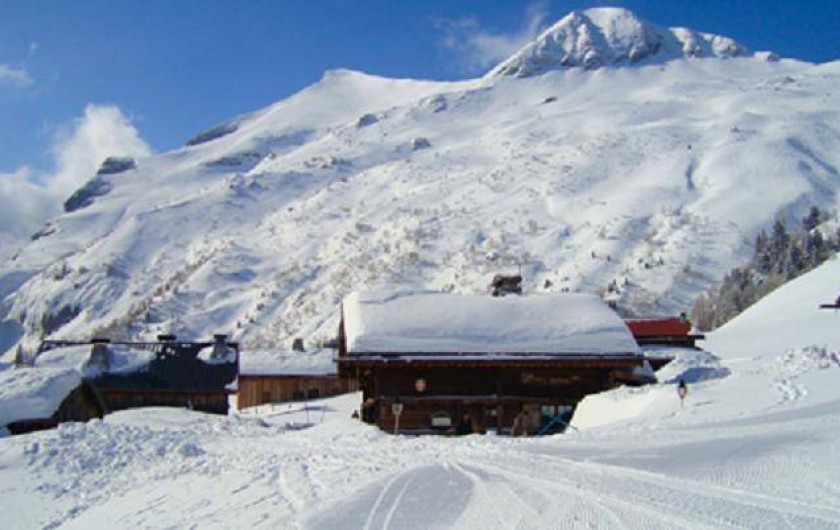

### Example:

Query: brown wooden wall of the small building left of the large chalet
xmin=236 ymin=374 xmax=358 ymax=409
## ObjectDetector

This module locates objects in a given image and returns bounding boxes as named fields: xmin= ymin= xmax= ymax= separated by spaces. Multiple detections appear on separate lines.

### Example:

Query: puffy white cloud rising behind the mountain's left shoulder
xmin=45 ymin=104 xmax=152 ymax=195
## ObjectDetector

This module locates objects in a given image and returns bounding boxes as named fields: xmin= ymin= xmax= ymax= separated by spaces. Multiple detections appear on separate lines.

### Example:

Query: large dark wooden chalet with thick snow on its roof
xmin=338 ymin=293 xmax=645 ymax=433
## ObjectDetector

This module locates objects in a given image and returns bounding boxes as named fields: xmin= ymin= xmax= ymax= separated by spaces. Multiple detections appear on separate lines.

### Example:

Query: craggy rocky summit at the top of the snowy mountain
xmin=488 ymin=7 xmax=748 ymax=77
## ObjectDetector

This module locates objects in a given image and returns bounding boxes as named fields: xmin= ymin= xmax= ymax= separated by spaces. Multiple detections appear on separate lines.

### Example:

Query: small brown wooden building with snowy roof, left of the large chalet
xmin=237 ymin=350 xmax=358 ymax=409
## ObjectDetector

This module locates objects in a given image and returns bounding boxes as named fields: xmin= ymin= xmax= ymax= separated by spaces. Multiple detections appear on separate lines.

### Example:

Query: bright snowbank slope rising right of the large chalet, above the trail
xmin=575 ymin=252 xmax=840 ymax=428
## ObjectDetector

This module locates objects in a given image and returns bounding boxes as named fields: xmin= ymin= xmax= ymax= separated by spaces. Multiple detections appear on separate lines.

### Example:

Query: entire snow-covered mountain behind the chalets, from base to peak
xmin=0 ymin=9 xmax=840 ymax=351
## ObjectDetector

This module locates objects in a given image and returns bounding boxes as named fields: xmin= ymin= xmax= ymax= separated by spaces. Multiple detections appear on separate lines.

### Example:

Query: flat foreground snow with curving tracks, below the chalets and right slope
xmin=0 ymin=382 xmax=840 ymax=529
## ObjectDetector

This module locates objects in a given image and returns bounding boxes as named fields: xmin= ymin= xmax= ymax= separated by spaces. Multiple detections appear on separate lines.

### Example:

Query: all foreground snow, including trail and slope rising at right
xmin=0 ymin=250 xmax=840 ymax=529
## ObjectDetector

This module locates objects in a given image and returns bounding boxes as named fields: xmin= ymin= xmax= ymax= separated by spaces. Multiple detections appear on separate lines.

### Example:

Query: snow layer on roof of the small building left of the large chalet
xmin=239 ymin=350 xmax=337 ymax=375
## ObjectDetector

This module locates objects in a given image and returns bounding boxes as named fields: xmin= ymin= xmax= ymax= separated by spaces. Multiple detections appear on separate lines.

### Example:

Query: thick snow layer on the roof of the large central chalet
xmin=342 ymin=292 xmax=639 ymax=355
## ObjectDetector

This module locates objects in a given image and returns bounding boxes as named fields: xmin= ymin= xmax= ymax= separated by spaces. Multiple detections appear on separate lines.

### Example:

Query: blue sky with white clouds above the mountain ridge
xmin=0 ymin=0 xmax=840 ymax=181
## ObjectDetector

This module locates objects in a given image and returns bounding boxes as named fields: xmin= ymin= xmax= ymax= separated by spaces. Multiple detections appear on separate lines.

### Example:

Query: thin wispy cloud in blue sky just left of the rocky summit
xmin=438 ymin=1 xmax=548 ymax=70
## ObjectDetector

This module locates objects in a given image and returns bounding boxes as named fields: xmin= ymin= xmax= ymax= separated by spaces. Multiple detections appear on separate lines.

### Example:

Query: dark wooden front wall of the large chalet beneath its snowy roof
xmin=339 ymin=356 xmax=641 ymax=434
